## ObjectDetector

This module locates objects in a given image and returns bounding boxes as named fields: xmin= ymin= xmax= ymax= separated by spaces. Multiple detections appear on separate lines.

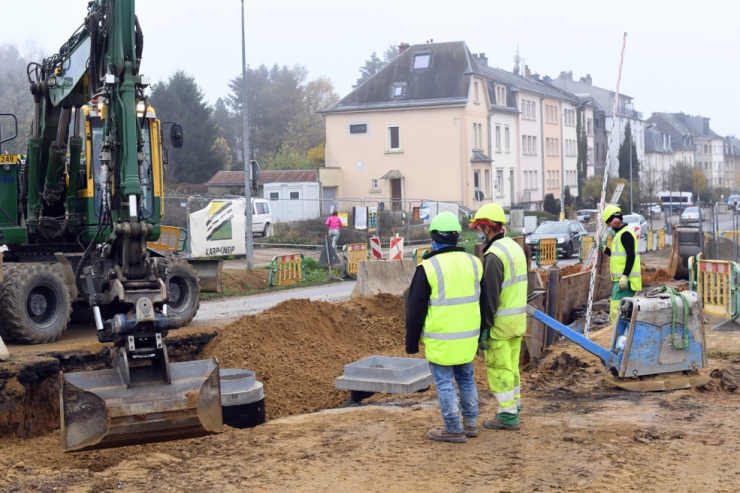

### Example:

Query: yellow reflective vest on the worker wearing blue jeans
xmin=421 ymin=252 xmax=483 ymax=366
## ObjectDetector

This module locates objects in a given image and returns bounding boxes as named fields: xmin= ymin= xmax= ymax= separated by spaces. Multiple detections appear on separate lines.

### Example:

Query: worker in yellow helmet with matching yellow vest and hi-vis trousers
xmin=470 ymin=204 xmax=529 ymax=430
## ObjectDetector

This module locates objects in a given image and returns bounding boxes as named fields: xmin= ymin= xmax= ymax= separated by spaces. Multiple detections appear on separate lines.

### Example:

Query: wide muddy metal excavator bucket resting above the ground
xmin=59 ymin=356 xmax=223 ymax=452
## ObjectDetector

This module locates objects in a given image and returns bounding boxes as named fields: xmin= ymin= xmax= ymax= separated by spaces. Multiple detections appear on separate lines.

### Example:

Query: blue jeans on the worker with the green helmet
xmin=429 ymin=361 xmax=478 ymax=433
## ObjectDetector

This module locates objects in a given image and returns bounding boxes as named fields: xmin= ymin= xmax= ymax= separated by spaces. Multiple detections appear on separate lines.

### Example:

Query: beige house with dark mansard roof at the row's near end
xmin=323 ymin=42 xmax=495 ymax=211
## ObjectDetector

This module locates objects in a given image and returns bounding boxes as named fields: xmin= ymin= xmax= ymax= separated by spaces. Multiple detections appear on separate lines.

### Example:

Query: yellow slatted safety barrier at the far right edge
xmin=689 ymin=254 xmax=740 ymax=320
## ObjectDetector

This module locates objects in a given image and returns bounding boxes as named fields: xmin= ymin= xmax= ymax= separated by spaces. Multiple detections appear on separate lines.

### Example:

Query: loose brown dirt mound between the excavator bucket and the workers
xmin=201 ymin=295 xmax=410 ymax=419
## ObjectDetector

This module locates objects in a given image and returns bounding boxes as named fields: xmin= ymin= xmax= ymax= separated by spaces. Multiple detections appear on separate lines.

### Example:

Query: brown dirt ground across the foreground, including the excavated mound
xmin=0 ymin=290 xmax=740 ymax=493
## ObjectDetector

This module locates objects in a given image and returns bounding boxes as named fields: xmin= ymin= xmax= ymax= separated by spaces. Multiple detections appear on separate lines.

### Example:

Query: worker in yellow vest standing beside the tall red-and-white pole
xmin=602 ymin=204 xmax=642 ymax=325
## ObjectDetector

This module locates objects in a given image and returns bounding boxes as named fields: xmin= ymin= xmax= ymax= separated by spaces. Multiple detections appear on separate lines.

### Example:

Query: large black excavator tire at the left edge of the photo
xmin=2 ymin=263 xmax=72 ymax=344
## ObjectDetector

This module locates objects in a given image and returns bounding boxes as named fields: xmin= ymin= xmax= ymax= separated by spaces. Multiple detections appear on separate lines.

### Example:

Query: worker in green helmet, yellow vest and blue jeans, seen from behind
xmin=406 ymin=212 xmax=483 ymax=443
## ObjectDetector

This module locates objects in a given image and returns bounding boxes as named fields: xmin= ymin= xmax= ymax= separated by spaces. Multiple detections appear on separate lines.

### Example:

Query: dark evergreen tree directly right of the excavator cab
xmin=149 ymin=70 xmax=225 ymax=183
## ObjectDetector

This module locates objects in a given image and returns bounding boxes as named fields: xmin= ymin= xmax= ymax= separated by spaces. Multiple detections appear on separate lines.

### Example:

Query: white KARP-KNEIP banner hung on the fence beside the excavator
xmin=188 ymin=200 xmax=247 ymax=258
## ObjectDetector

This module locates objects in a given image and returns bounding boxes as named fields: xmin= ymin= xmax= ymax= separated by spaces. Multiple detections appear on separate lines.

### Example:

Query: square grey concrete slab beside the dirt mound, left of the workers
xmin=334 ymin=356 xmax=434 ymax=394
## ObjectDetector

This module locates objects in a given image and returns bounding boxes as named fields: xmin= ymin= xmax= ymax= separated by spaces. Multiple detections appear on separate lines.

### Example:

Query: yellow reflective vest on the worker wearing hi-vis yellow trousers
xmin=486 ymin=237 xmax=529 ymax=339
